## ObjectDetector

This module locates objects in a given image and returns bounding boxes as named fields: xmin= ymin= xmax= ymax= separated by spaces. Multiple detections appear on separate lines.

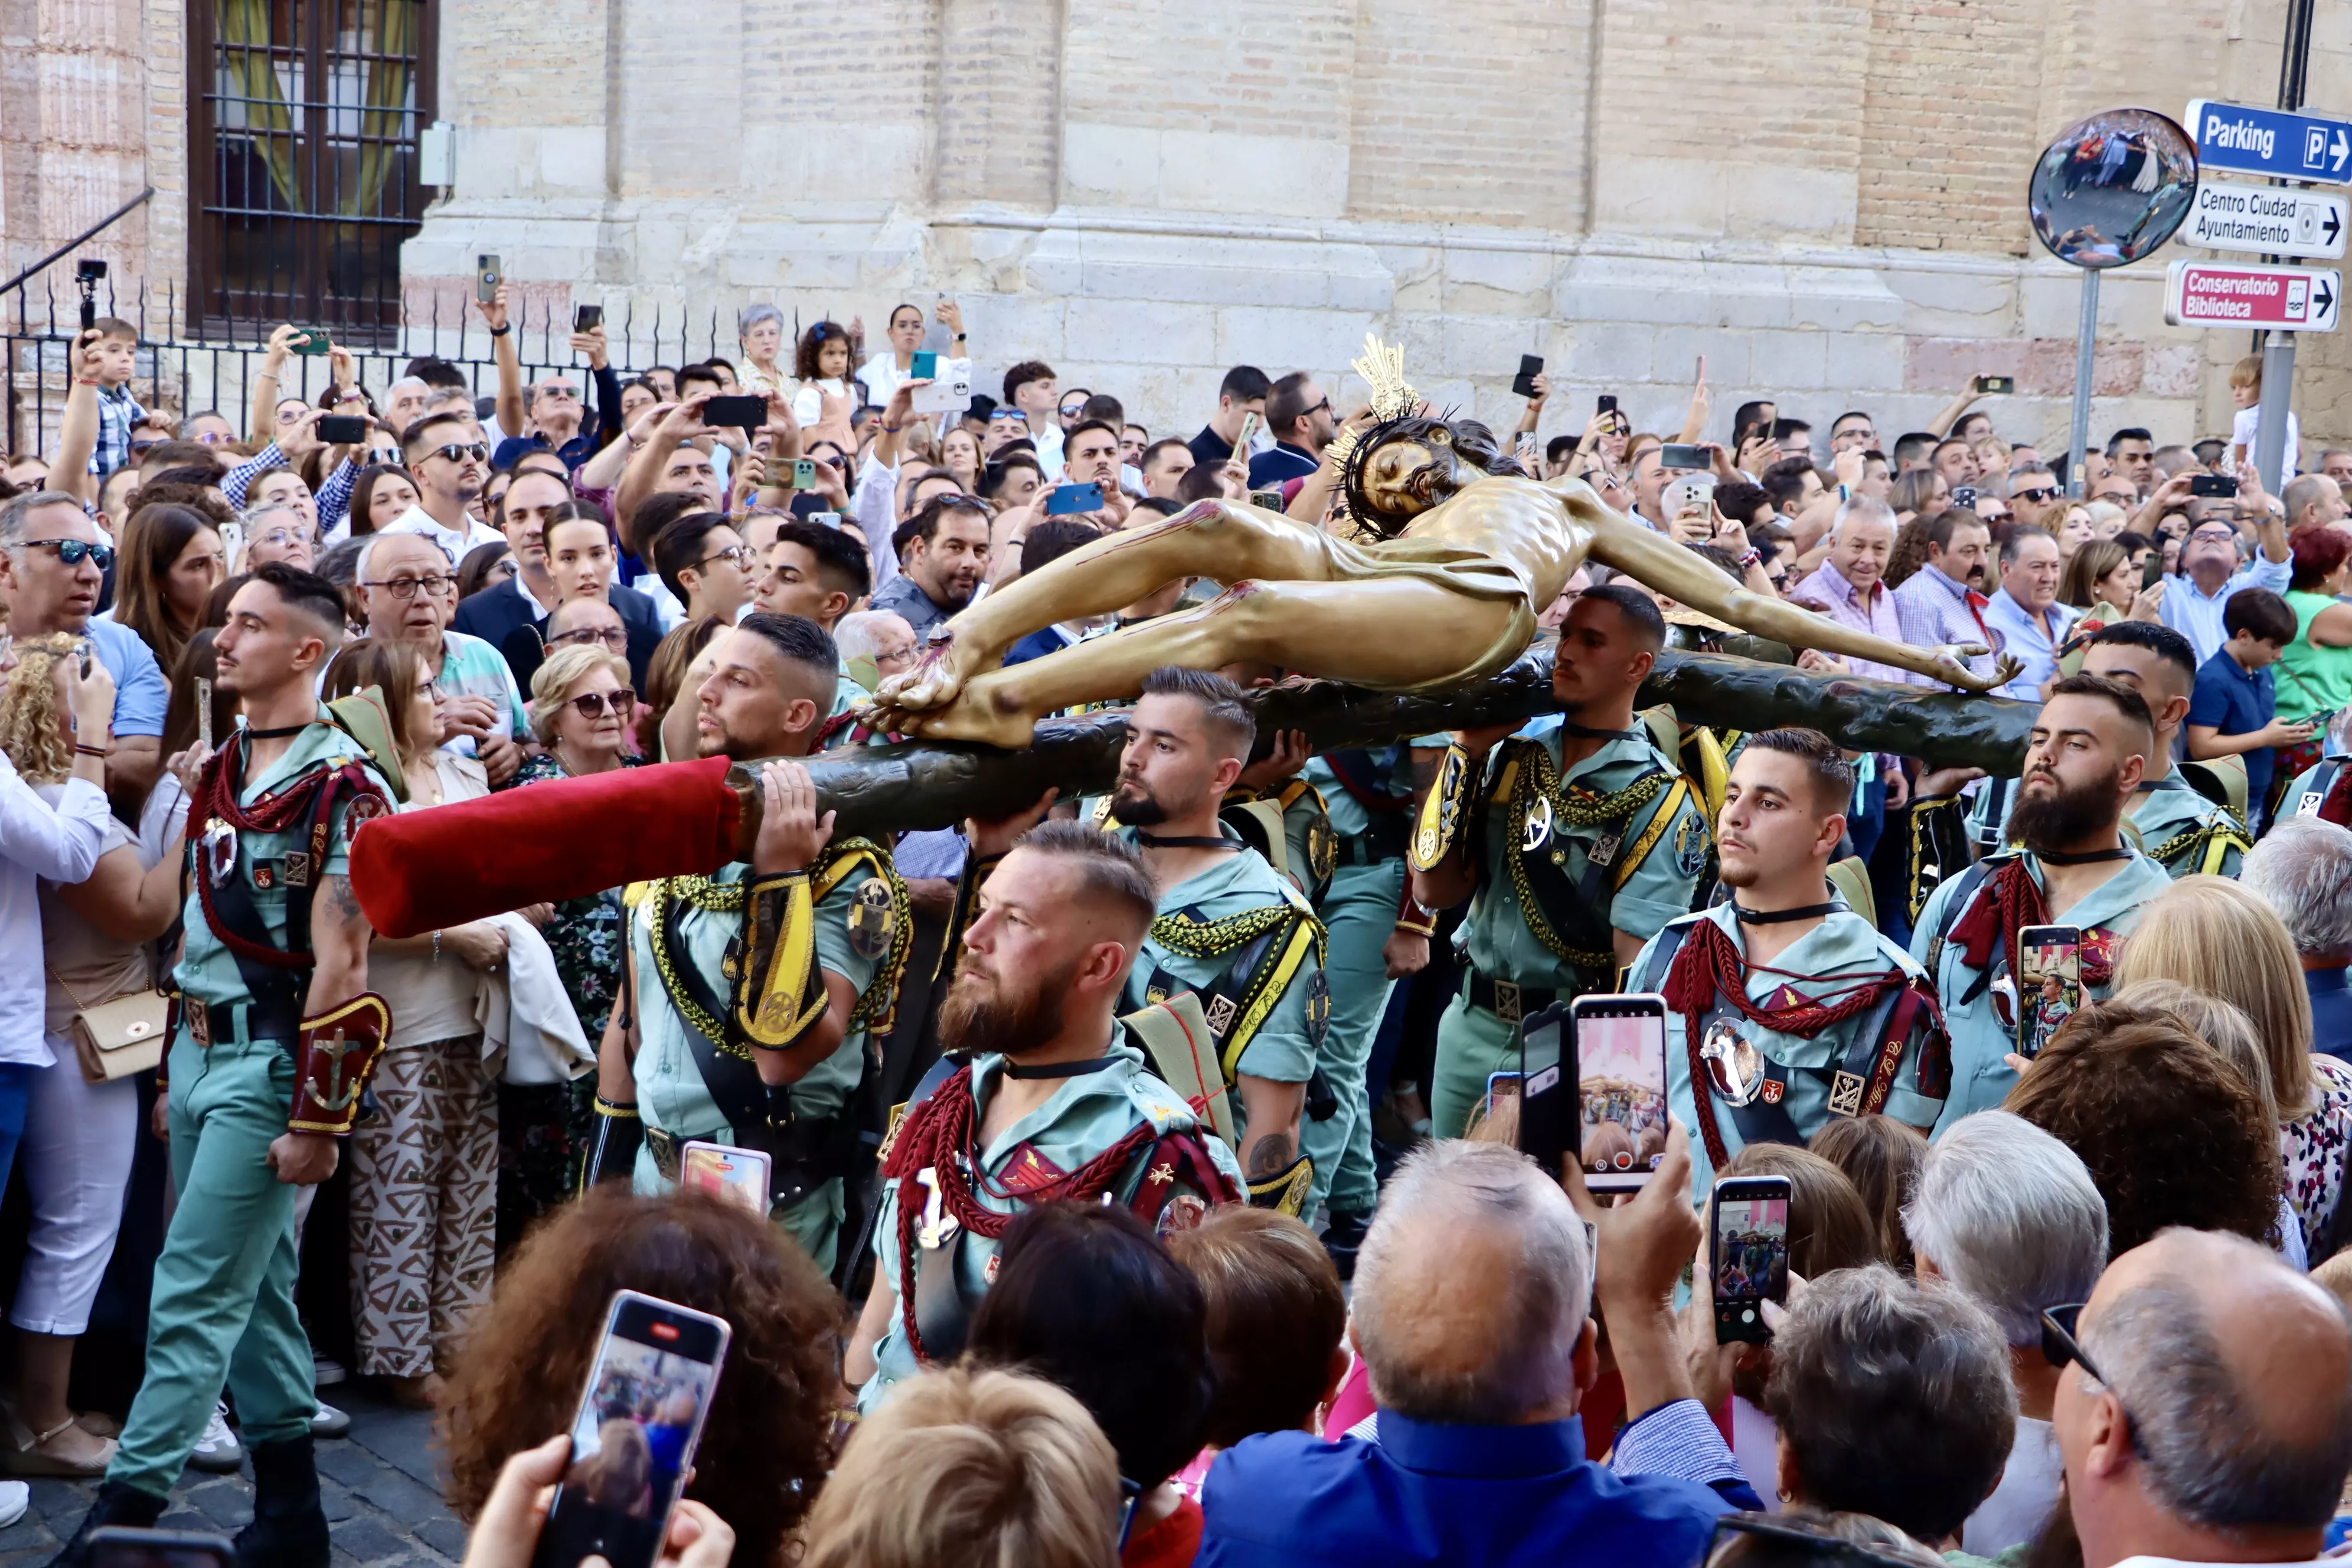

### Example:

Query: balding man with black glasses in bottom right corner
xmin=2044 ymin=1230 xmax=2352 ymax=1568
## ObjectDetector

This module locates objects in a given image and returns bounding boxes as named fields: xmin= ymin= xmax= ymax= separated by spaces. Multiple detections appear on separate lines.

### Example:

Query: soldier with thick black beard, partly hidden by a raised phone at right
xmin=1912 ymin=675 xmax=2171 ymax=1131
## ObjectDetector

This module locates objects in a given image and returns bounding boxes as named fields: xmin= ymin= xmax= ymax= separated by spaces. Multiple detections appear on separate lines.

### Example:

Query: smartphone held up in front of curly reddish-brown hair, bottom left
xmin=531 ymin=1291 xmax=729 ymax=1568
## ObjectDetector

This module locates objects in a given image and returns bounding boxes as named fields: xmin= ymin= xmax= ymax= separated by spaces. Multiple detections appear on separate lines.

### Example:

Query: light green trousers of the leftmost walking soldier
xmin=106 ymin=1030 xmax=318 ymax=1498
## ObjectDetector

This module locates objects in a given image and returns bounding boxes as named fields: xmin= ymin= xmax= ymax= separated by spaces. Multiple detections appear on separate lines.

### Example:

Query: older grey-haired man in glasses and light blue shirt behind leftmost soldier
xmin=358 ymin=534 xmax=529 ymax=788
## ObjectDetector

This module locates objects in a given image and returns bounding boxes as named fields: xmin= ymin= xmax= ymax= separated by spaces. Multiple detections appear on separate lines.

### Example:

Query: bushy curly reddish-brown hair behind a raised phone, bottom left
xmin=440 ymin=1185 xmax=844 ymax=1563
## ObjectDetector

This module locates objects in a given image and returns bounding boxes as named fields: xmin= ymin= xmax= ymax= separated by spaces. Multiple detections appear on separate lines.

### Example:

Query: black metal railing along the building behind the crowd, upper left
xmin=0 ymin=259 xmax=752 ymax=452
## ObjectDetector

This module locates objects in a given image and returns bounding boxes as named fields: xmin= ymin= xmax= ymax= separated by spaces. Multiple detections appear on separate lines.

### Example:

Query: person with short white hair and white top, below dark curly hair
xmin=1903 ymin=1110 xmax=2108 ymax=1556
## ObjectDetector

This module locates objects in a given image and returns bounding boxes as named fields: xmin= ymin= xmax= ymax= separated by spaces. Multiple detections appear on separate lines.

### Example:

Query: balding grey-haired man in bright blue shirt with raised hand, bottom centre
xmin=1195 ymin=1121 xmax=1757 ymax=1568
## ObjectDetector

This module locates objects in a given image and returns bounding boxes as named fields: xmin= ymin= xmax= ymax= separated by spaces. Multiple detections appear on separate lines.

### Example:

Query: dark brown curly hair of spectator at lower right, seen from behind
xmin=2001 ymin=1001 xmax=2281 ymax=1257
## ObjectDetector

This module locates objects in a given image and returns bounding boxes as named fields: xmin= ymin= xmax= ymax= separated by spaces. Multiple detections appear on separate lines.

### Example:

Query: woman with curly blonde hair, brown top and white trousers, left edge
xmin=0 ymin=635 xmax=158 ymax=1476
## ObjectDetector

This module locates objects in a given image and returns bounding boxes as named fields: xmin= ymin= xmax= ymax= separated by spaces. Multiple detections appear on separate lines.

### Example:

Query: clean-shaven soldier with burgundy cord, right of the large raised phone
xmin=1632 ymin=729 xmax=1952 ymax=1197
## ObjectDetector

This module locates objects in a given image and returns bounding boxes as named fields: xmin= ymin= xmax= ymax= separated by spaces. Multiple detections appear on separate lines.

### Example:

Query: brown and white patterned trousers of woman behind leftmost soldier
xmin=351 ymin=1034 xmax=499 ymax=1377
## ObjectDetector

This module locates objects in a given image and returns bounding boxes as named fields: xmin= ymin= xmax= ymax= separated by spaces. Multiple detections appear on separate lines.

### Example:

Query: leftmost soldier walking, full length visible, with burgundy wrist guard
xmin=66 ymin=562 xmax=397 ymax=1568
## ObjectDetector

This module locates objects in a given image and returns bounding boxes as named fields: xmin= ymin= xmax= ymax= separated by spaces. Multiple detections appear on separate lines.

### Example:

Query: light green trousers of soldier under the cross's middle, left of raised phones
xmin=1298 ymin=860 xmax=1404 ymax=1218
